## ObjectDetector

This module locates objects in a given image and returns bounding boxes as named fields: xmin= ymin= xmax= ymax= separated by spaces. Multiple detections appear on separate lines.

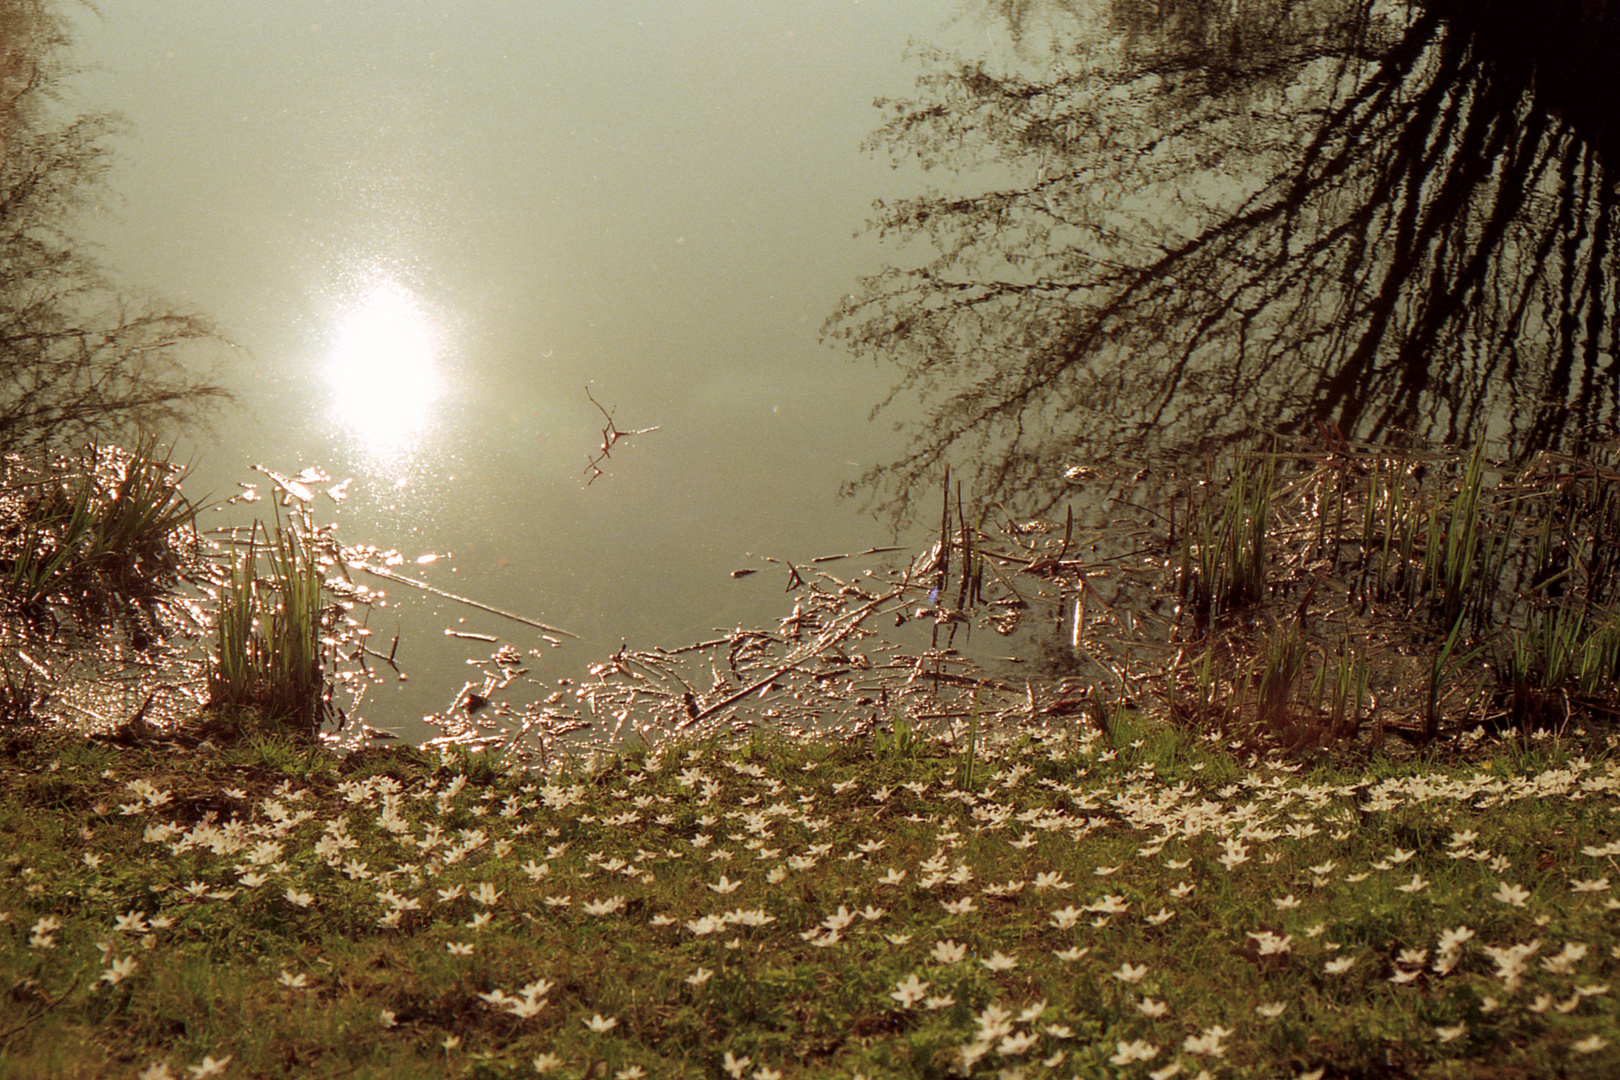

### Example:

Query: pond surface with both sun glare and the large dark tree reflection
xmin=47 ymin=0 xmax=1620 ymax=751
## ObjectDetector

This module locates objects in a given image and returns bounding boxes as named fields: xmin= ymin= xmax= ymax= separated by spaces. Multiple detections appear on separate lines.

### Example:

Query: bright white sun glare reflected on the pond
xmin=327 ymin=282 xmax=439 ymax=450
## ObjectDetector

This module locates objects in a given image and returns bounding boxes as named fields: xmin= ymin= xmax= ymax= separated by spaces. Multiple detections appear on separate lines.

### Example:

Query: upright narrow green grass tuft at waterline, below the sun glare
xmin=209 ymin=518 xmax=339 ymax=737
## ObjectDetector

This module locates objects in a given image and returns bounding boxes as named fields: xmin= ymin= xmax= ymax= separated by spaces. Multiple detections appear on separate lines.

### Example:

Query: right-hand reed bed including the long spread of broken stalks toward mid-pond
xmin=557 ymin=430 xmax=1620 ymax=761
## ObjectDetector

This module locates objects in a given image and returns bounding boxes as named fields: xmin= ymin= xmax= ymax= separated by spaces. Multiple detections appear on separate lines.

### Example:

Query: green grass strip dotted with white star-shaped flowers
xmin=0 ymin=712 xmax=1620 ymax=1080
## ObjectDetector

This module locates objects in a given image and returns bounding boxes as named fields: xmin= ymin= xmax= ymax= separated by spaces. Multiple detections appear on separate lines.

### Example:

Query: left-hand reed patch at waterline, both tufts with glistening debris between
xmin=0 ymin=439 xmax=377 ymax=737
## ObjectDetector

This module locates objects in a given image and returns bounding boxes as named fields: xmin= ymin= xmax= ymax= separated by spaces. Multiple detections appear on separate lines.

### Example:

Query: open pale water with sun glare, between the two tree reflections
xmin=66 ymin=0 xmax=1001 ymax=738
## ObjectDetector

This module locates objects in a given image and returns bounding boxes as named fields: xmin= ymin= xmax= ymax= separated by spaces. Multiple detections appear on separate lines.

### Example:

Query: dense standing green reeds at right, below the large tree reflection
xmin=1166 ymin=447 xmax=1620 ymax=745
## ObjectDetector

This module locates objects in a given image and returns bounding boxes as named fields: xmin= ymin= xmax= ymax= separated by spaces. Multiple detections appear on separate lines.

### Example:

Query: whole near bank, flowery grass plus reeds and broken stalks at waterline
xmin=9 ymin=433 xmax=1620 ymax=1080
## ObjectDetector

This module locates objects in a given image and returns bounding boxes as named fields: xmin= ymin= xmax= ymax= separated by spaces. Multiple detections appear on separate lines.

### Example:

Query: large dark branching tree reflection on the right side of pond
xmin=826 ymin=0 xmax=1620 ymax=517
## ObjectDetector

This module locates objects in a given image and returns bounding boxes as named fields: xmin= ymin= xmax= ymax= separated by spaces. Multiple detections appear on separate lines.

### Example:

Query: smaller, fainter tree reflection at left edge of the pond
xmin=0 ymin=0 xmax=228 ymax=453
